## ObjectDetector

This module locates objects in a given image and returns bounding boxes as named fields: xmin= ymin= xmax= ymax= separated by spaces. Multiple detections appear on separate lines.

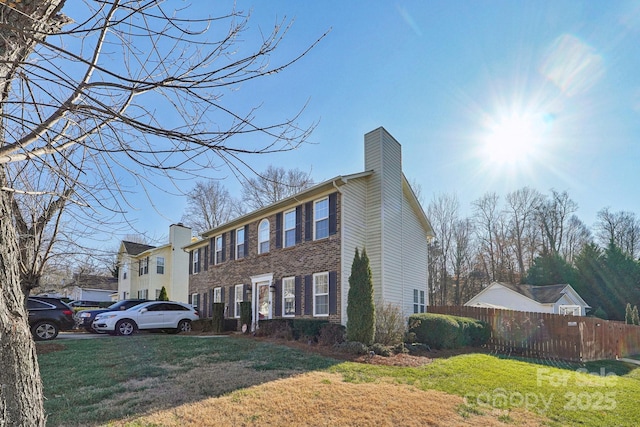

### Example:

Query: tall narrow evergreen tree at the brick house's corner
xmin=347 ymin=248 xmax=376 ymax=345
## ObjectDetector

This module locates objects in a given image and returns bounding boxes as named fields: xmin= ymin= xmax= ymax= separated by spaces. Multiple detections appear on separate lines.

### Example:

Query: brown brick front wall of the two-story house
xmin=189 ymin=193 xmax=342 ymax=323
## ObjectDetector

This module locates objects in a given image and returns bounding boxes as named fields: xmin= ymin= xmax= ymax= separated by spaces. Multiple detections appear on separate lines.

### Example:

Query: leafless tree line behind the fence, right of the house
xmin=427 ymin=187 xmax=640 ymax=305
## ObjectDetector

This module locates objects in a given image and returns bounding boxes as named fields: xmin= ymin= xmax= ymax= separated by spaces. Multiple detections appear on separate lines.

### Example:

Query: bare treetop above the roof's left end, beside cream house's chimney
xmin=182 ymin=179 xmax=244 ymax=234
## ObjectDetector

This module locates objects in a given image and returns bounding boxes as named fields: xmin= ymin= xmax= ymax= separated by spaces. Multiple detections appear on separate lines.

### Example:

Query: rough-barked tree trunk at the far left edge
xmin=0 ymin=0 xmax=66 ymax=427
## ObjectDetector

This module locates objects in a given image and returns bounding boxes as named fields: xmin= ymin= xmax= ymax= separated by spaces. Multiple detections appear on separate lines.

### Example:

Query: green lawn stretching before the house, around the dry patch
xmin=38 ymin=334 xmax=640 ymax=426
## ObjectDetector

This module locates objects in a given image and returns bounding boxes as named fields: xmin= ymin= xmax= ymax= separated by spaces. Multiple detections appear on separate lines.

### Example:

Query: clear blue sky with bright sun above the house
xmin=72 ymin=0 xmax=640 ymax=247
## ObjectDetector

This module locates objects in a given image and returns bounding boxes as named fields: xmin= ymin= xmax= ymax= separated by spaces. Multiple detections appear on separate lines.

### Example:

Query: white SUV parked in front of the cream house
xmin=91 ymin=301 xmax=200 ymax=335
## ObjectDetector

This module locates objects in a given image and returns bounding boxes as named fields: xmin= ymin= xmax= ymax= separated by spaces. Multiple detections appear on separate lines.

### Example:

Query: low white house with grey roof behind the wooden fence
xmin=465 ymin=282 xmax=591 ymax=316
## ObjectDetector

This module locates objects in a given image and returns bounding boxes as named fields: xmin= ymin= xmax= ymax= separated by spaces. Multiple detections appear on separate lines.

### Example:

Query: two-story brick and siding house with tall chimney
xmin=185 ymin=128 xmax=433 ymax=327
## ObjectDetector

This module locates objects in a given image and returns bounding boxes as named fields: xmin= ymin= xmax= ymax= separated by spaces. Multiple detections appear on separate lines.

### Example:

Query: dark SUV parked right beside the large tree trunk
xmin=27 ymin=297 xmax=75 ymax=341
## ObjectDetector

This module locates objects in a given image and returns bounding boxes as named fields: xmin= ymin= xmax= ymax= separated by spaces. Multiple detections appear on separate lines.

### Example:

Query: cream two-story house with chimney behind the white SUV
xmin=118 ymin=224 xmax=191 ymax=303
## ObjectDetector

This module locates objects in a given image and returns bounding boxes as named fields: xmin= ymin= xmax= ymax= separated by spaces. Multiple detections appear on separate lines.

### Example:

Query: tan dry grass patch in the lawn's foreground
xmin=110 ymin=372 xmax=544 ymax=427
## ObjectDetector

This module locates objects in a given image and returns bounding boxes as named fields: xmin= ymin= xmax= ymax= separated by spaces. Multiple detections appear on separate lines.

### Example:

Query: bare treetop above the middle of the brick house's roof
xmin=242 ymin=165 xmax=313 ymax=210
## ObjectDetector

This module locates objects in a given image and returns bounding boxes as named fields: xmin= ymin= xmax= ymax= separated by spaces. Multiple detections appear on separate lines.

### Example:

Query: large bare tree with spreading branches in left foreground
xmin=0 ymin=0 xmax=322 ymax=426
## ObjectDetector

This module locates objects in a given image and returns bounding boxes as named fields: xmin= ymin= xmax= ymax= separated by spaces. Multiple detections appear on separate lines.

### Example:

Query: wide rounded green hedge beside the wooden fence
xmin=409 ymin=313 xmax=491 ymax=348
